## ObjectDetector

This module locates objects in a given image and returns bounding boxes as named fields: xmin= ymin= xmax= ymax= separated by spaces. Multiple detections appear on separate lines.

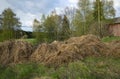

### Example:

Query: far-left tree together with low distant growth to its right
xmin=0 ymin=8 xmax=33 ymax=42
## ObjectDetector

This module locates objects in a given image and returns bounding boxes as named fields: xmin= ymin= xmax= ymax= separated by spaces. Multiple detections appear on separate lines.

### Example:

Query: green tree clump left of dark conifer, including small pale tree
xmin=33 ymin=14 xmax=62 ymax=43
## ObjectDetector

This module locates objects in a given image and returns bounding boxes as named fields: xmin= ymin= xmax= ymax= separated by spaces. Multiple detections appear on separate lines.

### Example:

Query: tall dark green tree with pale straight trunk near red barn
xmin=93 ymin=0 xmax=105 ymax=36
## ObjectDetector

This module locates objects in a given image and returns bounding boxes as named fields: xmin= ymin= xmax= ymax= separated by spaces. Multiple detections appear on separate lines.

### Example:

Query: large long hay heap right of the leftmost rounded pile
xmin=30 ymin=35 xmax=110 ymax=67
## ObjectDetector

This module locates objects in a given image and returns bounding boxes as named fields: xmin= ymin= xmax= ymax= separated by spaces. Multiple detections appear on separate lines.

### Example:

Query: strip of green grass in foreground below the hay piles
xmin=0 ymin=57 xmax=120 ymax=79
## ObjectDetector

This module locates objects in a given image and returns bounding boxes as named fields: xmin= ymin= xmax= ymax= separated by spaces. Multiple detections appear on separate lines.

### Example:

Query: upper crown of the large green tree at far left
xmin=1 ymin=8 xmax=21 ymax=29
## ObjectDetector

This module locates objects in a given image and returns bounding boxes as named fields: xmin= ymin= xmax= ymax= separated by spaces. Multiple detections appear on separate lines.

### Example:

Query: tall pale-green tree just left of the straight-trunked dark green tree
xmin=73 ymin=0 xmax=93 ymax=36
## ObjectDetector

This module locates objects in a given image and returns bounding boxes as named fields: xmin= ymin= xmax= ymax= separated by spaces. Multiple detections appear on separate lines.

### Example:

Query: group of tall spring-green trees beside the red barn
xmin=73 ymin=0 xmax=115 ymax=37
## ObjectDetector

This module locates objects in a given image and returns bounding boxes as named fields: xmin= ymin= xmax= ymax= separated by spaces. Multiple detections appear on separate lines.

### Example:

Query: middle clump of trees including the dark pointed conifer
xmin=33 ymin=13 xmax=71 ymax=42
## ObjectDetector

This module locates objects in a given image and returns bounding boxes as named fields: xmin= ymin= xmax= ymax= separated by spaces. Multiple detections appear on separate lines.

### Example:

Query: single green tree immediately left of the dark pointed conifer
xmin=44 ymin=11 xmax=61 ymax=42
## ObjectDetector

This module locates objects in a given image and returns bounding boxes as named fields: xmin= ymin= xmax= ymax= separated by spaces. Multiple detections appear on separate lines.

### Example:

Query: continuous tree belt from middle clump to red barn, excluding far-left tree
xmin=33 ymin=0 xmax=115 ymax=42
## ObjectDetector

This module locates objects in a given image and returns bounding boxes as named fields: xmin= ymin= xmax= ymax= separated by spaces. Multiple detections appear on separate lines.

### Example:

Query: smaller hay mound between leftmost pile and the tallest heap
xmin=30 ymin=43 xmax=58 ymax=62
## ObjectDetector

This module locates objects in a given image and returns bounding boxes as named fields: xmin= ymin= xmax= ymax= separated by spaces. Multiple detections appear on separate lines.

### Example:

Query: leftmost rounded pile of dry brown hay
xmin=0 ymin=41 xmax=32 ymax=65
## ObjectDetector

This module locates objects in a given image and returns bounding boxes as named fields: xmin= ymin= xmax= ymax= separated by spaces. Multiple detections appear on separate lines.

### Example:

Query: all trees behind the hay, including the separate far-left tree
xmin=0 ymin=0 xmax=115 ymax=42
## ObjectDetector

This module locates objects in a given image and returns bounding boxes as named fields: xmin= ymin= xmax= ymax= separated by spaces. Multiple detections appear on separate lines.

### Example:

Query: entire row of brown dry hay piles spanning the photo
xmin=0 ymin=35 xmax=120 ymax=67
